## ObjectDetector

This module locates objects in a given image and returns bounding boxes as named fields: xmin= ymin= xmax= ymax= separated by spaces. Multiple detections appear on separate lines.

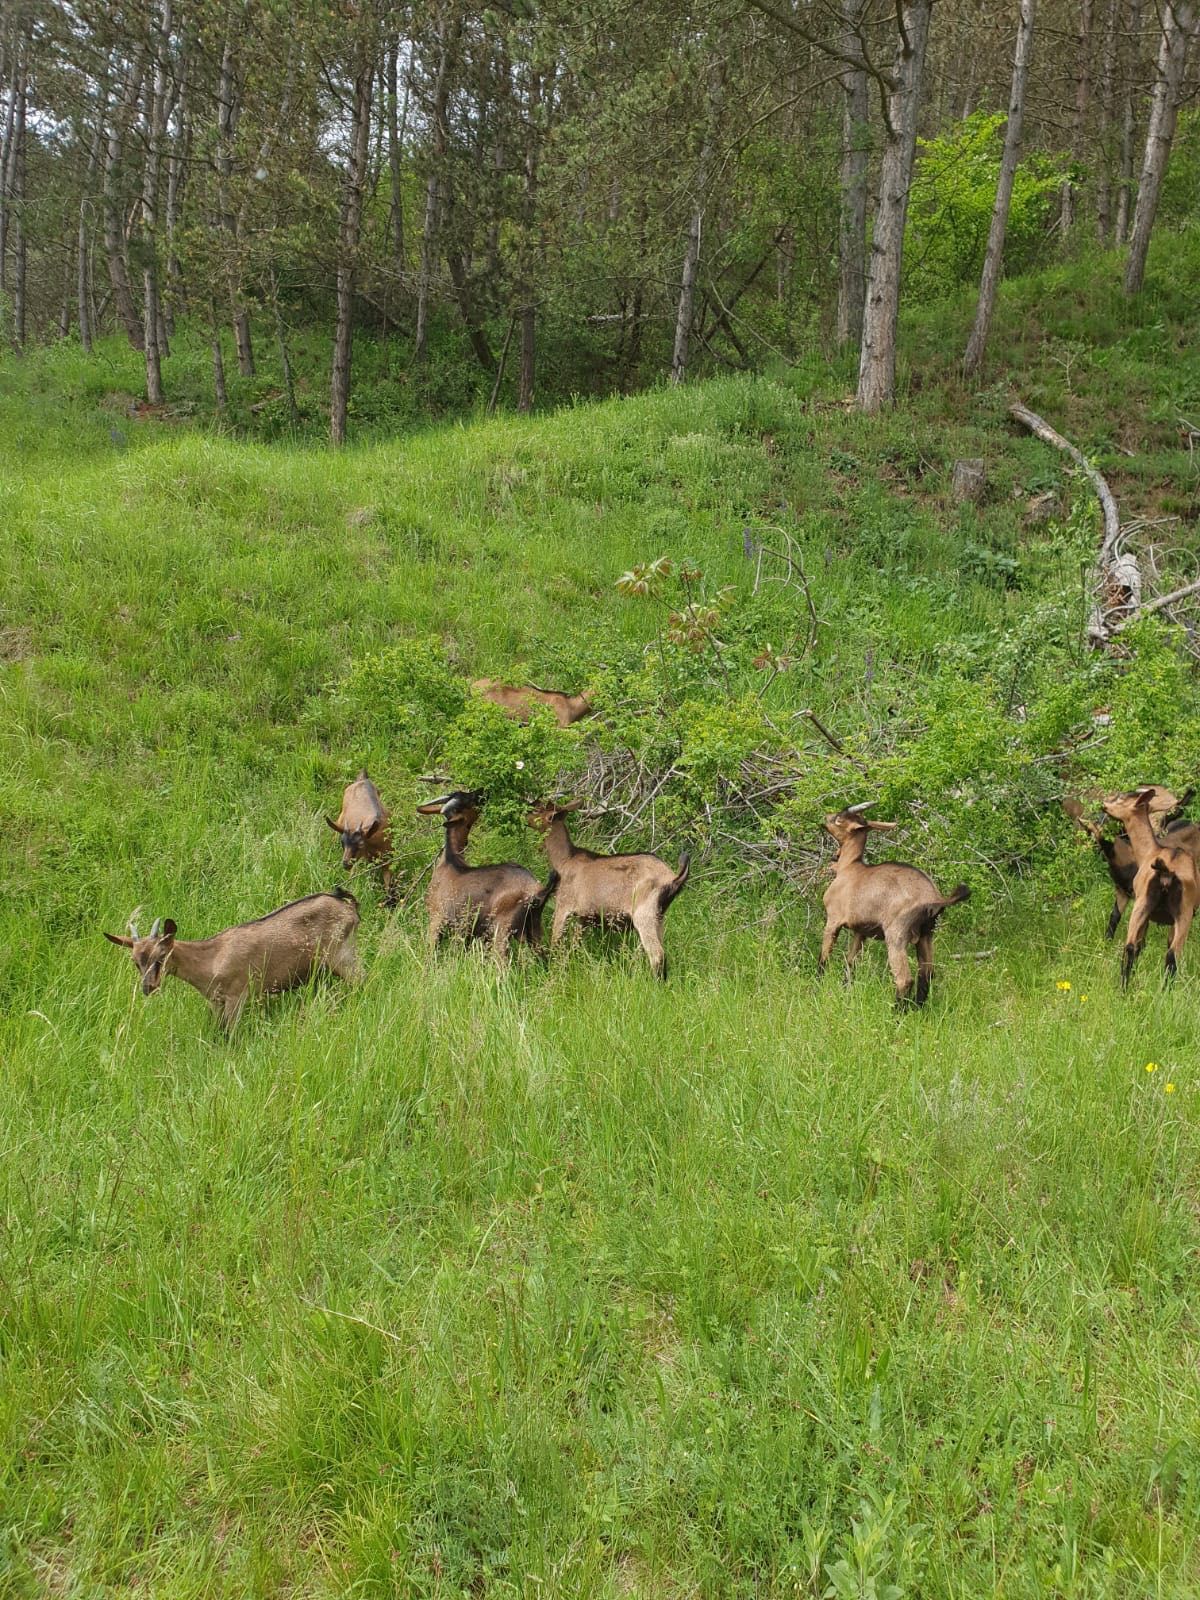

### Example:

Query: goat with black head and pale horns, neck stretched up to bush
xmin=416 ymin=789 xmax=558 ymax=962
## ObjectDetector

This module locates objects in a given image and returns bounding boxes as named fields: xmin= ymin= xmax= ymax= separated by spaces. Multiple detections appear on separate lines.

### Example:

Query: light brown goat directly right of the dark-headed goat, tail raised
xmin=528 ymin=800 xmax=690 ymax=978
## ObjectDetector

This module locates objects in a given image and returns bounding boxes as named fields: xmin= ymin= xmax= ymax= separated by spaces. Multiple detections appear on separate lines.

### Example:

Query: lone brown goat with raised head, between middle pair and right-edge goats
xmin=818 ymin=802 xmax=971 ymax=1005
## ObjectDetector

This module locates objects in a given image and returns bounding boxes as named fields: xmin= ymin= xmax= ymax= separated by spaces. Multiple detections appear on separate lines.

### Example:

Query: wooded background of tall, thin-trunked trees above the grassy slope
xmin=0 ymin=0 xmax=1200 ymax=443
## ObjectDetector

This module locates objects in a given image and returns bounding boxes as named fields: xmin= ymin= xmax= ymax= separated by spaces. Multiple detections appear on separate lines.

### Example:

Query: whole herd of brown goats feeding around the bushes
xmin=104 ymin=678 xmax=1200 ymax=1029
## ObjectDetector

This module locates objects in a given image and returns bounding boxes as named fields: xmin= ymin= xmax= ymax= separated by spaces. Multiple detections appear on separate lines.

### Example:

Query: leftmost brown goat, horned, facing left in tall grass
xmin=104 ymin=888 xmax=362 ymax=1032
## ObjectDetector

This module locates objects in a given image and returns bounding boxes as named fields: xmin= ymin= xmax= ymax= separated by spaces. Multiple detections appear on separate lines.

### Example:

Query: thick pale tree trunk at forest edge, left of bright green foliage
xmin=858 ymin=0 xmax=933 ymax=413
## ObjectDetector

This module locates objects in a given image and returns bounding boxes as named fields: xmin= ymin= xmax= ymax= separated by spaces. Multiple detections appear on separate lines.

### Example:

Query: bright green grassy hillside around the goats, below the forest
xmin=0 ymin=242 xmax=1200 ymax=1600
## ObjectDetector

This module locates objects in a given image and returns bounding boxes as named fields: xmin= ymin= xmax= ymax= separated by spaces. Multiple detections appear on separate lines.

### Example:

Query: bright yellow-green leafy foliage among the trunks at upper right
xmin=904 ymin=110 xmax=1067 ymax=299
